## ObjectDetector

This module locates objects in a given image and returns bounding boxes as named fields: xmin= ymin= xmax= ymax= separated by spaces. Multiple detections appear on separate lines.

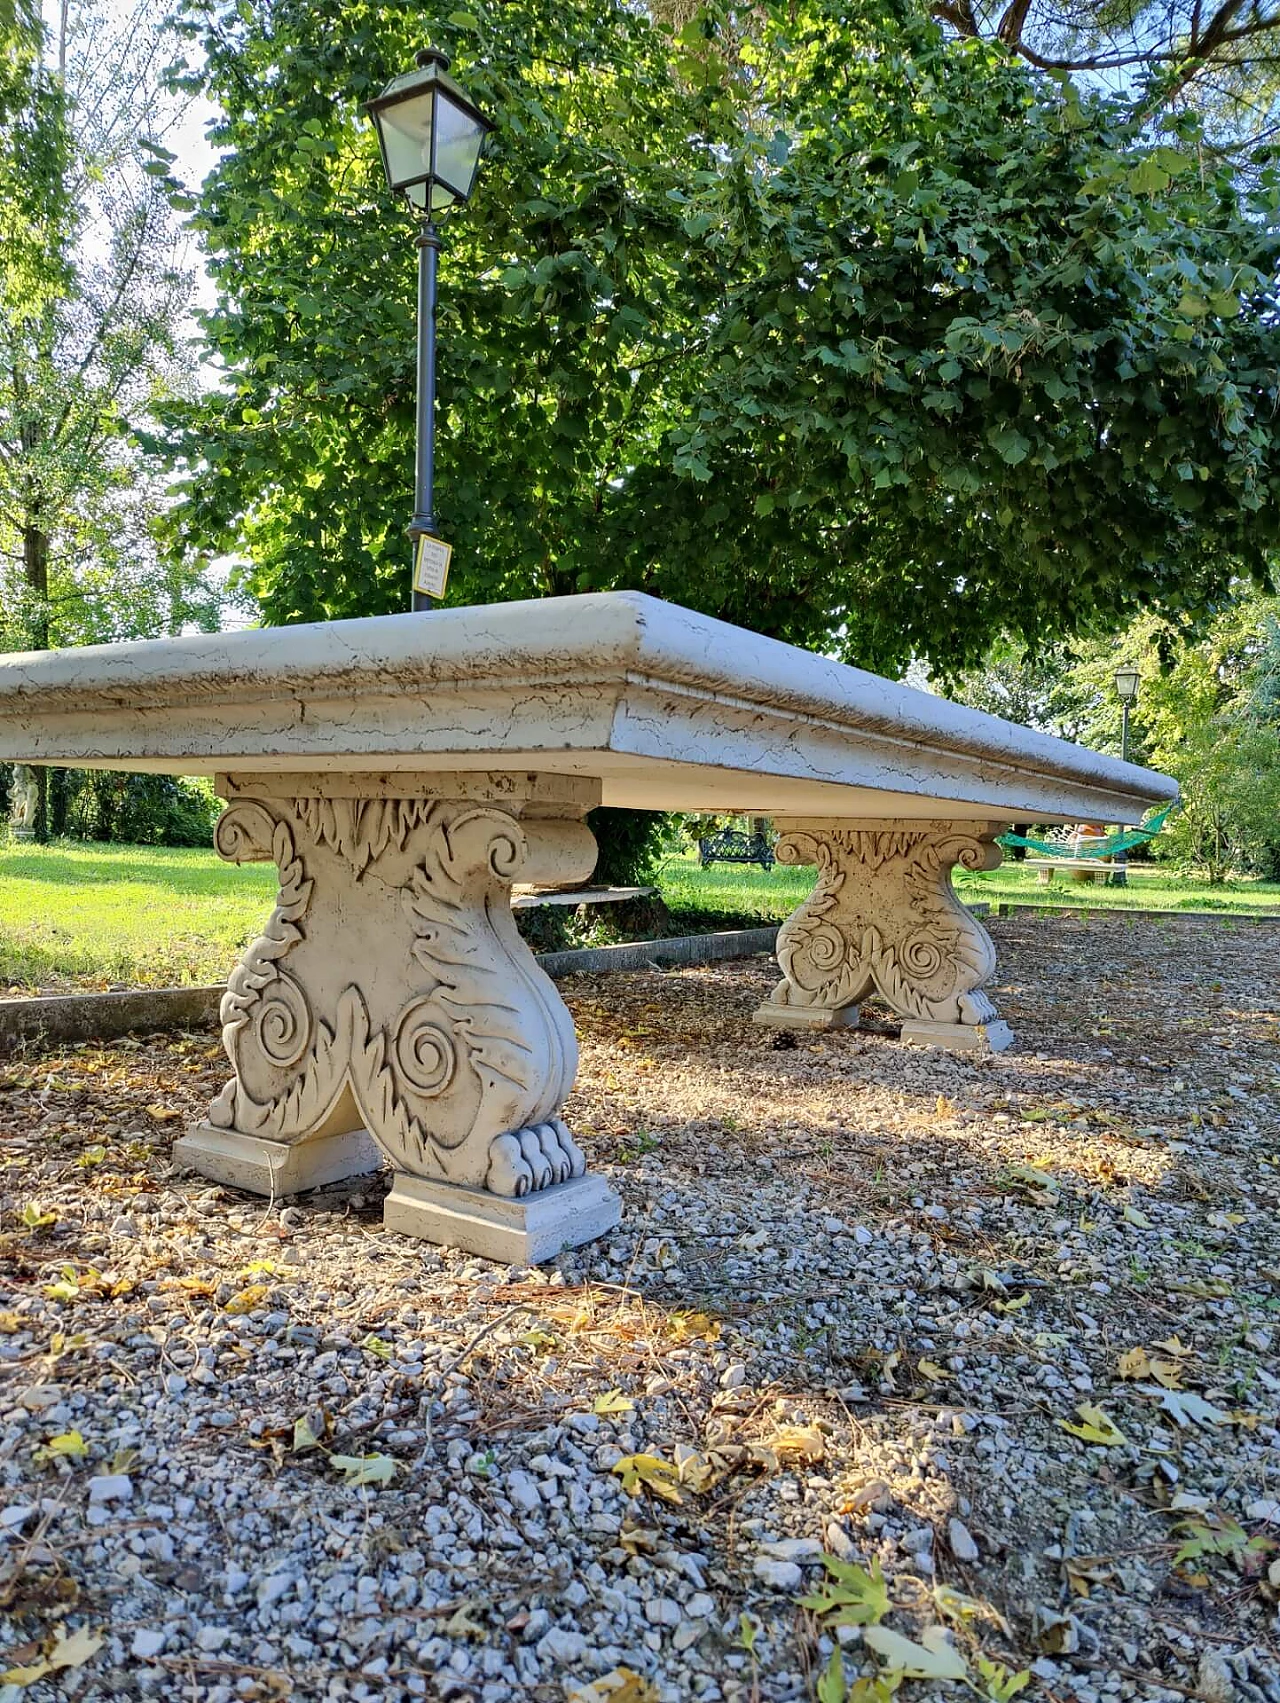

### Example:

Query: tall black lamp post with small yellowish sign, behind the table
xmin=366 ymin=48 xmax=494 ymax=610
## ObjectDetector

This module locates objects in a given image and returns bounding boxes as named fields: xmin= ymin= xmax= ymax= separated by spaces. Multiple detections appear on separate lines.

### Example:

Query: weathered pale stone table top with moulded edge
xmin=0 ymin=591 xmax=1178 ymax=823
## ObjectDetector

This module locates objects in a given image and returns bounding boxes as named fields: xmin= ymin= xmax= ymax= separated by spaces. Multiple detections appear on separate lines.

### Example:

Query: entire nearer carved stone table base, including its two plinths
xmin=175 ymin=773 xmax=620 ymax=1262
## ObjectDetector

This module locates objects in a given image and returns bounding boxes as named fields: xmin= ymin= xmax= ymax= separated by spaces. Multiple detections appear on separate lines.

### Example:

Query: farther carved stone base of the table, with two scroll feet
xmin=756 ymin=819 xmax=1013 ymax=1052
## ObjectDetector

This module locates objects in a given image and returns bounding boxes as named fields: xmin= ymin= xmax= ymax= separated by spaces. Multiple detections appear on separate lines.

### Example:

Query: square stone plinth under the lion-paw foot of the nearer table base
xmin=383 ymin=1172 xmax=623 ymax=1265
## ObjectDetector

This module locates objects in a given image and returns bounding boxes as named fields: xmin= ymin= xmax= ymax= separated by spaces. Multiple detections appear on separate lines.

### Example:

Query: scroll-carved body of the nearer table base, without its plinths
xmin=209 ymin=799 xmax=586 ymax=1196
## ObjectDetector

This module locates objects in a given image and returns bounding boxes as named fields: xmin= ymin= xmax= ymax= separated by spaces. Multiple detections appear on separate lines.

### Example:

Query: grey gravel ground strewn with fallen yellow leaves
xmin=0 ymin=916 xmax=1280 ymax=1703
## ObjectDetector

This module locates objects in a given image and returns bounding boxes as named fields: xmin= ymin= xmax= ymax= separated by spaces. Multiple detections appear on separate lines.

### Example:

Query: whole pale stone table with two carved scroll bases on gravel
xmin=0 ymin=593 xmax=1176 ymax=1262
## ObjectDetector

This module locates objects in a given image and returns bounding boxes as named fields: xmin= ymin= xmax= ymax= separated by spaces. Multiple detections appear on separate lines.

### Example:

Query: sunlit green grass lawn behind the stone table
xmin=0 ymin=843 xmax=1280 ymax=993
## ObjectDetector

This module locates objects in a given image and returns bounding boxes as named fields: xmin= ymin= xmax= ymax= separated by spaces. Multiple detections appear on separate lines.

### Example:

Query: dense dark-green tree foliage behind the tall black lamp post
xmin=165 ymin=0 xmax=1280 ymax=669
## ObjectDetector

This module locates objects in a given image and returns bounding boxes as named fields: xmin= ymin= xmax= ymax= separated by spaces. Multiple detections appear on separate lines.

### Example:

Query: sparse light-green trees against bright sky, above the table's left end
xmin=0 ymin=0 xmax=218 ymax=651
